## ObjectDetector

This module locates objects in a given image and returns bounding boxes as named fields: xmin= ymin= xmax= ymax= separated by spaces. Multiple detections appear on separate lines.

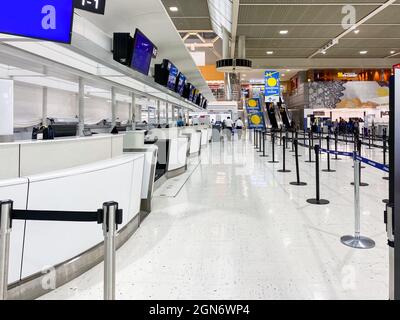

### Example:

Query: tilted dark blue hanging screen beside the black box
xmin=131 ymin=29 xmax=157 ymax=76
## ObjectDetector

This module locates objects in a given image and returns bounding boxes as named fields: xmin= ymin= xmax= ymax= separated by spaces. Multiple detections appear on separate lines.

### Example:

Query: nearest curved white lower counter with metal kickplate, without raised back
xmin=0 ymin=154 xmax=144 ymax=299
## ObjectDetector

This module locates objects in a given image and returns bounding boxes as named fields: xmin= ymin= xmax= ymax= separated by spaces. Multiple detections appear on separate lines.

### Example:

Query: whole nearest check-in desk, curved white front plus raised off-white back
xmin=0 ymin=135 xmax=145 ymax=299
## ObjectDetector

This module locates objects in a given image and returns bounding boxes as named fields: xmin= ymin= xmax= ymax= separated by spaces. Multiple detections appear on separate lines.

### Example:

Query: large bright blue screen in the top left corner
xmin=0 ymin=0 xmax=74 ymax=43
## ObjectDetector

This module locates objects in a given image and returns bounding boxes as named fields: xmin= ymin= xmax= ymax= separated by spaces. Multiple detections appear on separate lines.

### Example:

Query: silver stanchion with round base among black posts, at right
xmin=341 ymin=152 xmax=375 ymax=249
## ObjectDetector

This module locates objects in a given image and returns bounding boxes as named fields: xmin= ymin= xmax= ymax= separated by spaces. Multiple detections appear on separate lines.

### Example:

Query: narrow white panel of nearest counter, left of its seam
xmin=0 ymin=179 xmax=28 ymax=283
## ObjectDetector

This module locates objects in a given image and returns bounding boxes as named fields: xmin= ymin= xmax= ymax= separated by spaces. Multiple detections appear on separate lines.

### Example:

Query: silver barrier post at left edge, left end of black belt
xmin=0 ymin=200 xmax=13 ymax=300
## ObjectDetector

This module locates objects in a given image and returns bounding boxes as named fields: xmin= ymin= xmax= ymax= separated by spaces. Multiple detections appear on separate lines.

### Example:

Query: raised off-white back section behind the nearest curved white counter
xmin=0 ymin=134 xmax=123 ymax=180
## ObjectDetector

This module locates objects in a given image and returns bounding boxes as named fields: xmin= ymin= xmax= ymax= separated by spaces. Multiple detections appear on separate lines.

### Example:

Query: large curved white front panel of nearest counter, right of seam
xmin=22 ymin=155 xmax=143 ymax=277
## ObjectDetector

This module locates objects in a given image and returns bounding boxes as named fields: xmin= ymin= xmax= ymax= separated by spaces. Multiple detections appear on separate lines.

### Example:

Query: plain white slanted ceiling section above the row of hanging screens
xmin=77 ymin=0 xmax=213 ymax=100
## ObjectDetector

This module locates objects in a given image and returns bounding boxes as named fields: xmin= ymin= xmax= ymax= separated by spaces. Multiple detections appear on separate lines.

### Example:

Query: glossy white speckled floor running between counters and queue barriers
xmin=42 ymin=132 xmax=388 ymax=299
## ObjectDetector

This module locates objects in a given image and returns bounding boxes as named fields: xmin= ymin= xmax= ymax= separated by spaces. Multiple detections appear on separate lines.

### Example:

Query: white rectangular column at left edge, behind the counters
xmin=0 ymin=79 xmax=14 ymax=142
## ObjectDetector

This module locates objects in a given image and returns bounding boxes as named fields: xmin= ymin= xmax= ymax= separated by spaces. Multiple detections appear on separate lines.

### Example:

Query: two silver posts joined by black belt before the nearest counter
xmin=0 ymin=200 xmax=123 ymax=300
